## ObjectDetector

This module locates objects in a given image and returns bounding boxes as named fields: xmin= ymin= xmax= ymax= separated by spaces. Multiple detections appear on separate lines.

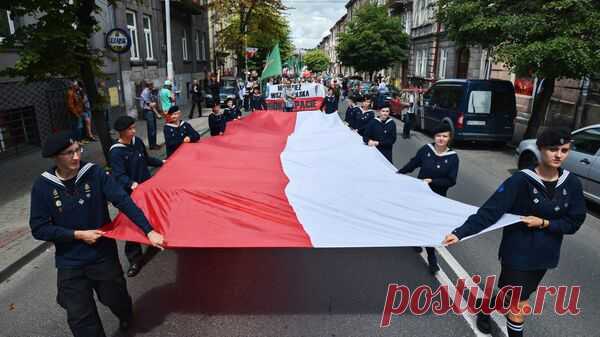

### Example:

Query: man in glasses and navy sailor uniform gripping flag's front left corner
xmin=29 ymin=131 xmax=164 ymax=337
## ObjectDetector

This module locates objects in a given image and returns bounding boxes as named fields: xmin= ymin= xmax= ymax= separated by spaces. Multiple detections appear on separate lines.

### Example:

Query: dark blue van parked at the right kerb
xmin=416 ymin=79 xmax=517 ymax=142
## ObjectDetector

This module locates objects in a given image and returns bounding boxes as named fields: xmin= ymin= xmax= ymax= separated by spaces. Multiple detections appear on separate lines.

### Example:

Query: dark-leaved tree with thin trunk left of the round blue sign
xmin=0 ymin=0 xmax=116 ymax=158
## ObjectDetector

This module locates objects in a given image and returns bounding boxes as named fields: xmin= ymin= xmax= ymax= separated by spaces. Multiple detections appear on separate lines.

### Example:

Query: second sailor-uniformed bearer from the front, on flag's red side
xmin=108 ymin=116 xmax=164 ymax=277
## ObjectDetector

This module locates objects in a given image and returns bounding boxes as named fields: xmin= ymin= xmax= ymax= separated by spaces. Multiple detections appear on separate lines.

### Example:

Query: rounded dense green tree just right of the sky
xmin=336 ymin=4 xmax=408 ymax=77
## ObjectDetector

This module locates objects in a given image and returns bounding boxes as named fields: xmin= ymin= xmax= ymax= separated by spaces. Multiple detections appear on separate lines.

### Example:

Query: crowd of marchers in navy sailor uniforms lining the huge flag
xmin=30 ymin=75 xmax=586 ymax=337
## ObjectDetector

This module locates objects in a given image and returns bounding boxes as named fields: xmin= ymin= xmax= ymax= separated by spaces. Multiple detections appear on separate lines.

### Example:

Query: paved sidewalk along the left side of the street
xmin=0 ymin=108 xmax=210 ymax=282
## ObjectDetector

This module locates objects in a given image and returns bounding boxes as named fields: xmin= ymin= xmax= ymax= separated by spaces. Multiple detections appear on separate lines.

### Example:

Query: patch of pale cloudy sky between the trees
xmin=283 ymin=0 xmax=348 ymax=48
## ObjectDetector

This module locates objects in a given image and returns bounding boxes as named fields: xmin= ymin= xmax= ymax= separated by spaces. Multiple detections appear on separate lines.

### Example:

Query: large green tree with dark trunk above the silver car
xmin=437 ymin=0 xmax=600 ymax=138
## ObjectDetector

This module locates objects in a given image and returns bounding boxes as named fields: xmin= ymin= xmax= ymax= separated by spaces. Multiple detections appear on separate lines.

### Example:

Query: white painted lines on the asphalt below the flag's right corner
xmin=420 ymin=247 xmax=508 ymax=337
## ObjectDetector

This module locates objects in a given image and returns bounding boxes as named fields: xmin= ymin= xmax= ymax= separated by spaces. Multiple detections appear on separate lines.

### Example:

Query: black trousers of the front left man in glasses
xmin=56 ymin=259 xmax=133 ymax=337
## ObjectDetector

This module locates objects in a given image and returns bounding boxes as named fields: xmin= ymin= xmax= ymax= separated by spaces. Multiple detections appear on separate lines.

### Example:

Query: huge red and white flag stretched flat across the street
xmin=104 ymin=111 xmax=519 ymax=247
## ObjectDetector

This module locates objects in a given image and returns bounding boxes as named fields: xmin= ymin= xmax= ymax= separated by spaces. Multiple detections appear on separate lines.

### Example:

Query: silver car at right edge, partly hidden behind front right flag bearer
xmin=517 ymin=124 xmax=600 ymax=203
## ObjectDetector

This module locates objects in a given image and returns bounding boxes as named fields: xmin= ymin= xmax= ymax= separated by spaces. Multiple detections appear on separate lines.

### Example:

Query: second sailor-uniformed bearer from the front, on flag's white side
xmin=398 ymin=123 xmax=459 ymax=274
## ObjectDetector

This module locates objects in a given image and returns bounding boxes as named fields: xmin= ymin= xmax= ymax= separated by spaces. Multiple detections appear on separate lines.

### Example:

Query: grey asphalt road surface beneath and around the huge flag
xmin=0 ymin=108 xmax=600 ymax=337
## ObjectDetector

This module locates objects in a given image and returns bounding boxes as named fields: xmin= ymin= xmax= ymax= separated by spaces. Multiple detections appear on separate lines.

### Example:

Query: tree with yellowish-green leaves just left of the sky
xmin=211 ymin=0 xmax=294 ymax=76
